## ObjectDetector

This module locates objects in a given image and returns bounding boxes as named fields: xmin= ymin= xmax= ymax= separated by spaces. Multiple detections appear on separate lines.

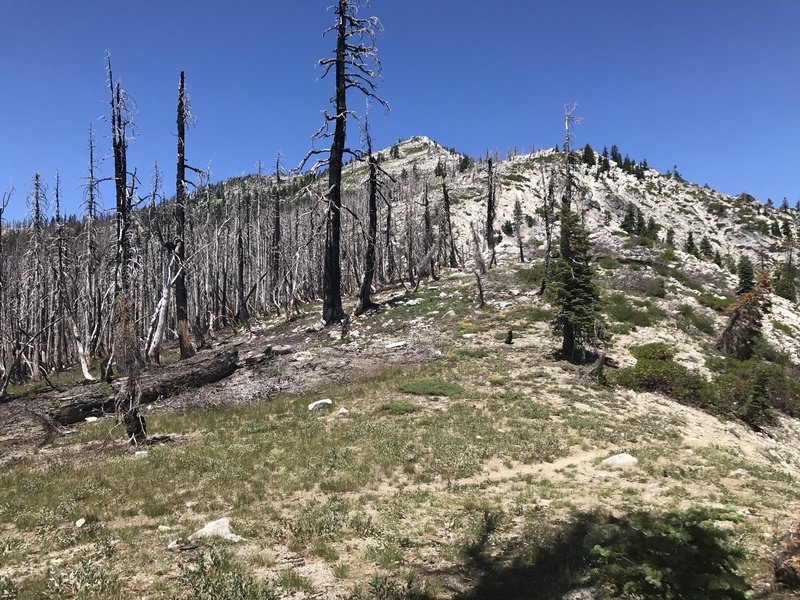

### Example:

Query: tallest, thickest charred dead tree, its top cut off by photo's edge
xmin=304 ymin=0 xmax=389 ymax=324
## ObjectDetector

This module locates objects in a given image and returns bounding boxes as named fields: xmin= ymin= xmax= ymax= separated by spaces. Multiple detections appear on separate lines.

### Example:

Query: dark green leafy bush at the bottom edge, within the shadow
xmin=589 ymin=508 xmax=751 ymax=600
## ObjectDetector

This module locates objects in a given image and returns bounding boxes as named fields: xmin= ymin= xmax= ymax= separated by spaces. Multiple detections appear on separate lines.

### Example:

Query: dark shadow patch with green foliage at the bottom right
xmin=399 ymin=508 xmax=751 ymax=600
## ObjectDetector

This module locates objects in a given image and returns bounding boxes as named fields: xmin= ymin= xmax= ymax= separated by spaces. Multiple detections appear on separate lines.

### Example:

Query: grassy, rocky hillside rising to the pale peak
xmin=0 ymin=137 xmax=800 ymax=600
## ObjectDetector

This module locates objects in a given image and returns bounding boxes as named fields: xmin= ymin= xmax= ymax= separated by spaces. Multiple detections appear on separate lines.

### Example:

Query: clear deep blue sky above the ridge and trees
xmin=0 ymin=0 xmax=800 ymax=218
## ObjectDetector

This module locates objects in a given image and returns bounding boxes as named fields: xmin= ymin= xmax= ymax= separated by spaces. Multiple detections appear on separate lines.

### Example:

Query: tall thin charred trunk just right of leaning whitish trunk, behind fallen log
xmin=175 ymin=71 xmax=194 ymax=359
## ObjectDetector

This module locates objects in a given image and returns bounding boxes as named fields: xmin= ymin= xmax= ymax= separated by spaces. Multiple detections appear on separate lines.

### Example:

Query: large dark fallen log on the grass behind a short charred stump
xmin=50 ymin=349 xmax=239 ymax=425
